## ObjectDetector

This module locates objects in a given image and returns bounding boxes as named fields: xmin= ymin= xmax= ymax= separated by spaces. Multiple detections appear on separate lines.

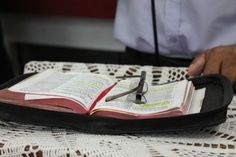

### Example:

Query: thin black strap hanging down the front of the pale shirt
xmin=151 ymin=0 xmax=159 ymax=65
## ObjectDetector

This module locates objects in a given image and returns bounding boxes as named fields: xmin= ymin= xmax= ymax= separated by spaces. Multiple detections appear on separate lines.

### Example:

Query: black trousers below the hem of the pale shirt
xmin=120 ymin=47 xmax=192 ymax=67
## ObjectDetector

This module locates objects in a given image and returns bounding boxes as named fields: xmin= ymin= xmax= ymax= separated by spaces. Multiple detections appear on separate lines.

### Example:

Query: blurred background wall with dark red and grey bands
xmin=0 ymin=0 xmax=125 ymax=74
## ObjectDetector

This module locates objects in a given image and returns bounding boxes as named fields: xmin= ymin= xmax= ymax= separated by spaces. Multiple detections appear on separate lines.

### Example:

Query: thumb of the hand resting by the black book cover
xmin=188 ymin=53 xmax=206 ymax=76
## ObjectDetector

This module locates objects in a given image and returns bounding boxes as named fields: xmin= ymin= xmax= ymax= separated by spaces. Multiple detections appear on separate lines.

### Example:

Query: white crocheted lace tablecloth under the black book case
xmin=0 ymin=61 xmax=236 ymax=157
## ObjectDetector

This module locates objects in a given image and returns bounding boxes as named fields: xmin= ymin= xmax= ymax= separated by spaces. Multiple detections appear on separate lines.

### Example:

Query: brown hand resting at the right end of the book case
xmin=188 ymin=45 xmax=236 ymax=89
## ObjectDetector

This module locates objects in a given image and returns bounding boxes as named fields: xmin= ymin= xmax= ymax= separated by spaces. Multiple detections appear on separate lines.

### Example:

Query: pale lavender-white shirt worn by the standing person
xmin=115 ymin=0 xmax=236 ymax=58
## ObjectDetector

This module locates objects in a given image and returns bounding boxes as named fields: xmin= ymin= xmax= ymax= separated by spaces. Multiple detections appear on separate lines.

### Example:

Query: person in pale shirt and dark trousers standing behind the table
xmin=114 ymin=0 xmax=236 ymax=87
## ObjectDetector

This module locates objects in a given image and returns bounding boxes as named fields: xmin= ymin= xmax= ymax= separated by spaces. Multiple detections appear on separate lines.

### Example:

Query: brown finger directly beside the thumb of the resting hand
xmin=203 ymin=49 xmax=222 ymax=75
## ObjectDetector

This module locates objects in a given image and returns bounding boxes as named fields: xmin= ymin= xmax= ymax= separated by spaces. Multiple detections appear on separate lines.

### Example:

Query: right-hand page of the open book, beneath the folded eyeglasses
xmin=92 ymin=80 xmax=189 ymax=114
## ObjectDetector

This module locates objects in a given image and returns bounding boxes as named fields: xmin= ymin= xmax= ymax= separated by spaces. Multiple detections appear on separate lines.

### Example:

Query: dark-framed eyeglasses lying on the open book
xmin=105 ymin=71 xmax=148 ymax=104
